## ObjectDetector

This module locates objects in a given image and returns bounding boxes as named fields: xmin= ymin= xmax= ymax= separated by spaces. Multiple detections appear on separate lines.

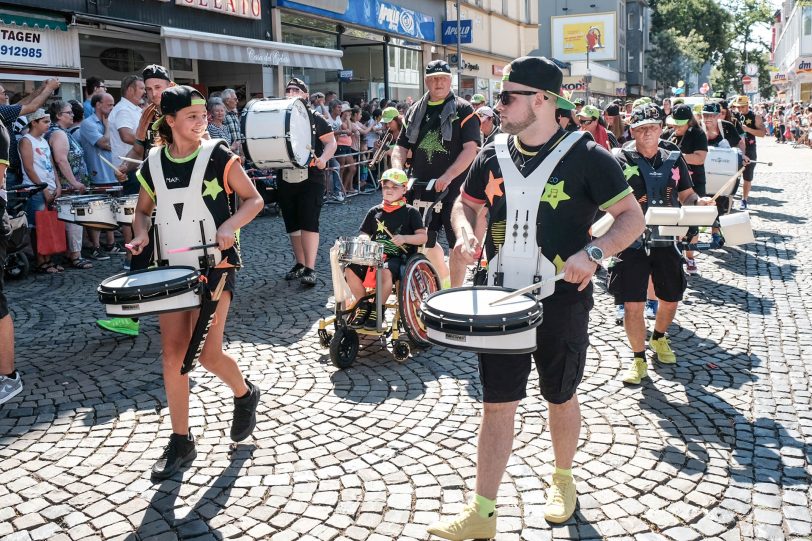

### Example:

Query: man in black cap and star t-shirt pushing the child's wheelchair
xmin=392 ymin=60 xmax=480 ymax=288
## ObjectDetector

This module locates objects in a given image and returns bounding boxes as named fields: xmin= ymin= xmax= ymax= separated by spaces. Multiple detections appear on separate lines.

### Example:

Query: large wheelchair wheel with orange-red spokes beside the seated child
xmin=398 ymin=254 xmax=440 ymax=347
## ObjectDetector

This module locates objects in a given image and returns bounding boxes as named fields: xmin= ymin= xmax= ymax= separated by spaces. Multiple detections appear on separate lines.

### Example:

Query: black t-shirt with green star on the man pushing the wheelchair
xmin=397 ymin=93 xmax=481 ymax=191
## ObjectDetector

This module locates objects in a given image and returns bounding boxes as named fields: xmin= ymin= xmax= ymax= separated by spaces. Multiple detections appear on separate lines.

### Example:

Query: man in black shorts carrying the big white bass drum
xmin=276 ymin=77 xmax=337 ymax=287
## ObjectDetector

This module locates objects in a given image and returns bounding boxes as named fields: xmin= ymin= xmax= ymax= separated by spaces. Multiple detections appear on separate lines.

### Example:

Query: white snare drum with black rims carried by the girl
xmin=97 ymin=266 xmax=200 ymax=317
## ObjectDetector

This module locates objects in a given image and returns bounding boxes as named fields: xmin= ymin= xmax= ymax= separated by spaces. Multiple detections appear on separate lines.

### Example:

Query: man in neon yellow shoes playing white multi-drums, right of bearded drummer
xmin=608 ymin=103 xmax=714 ymax=384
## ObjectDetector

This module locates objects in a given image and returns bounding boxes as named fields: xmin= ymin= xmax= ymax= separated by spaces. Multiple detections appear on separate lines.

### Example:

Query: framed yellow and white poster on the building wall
xmin=550 ymin=12 xmax=617 ymax=62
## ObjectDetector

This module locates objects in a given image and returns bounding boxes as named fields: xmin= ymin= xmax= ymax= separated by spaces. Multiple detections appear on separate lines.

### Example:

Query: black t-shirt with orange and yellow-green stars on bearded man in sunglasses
xmin=462 ymin=129 xmax=631 ymax=299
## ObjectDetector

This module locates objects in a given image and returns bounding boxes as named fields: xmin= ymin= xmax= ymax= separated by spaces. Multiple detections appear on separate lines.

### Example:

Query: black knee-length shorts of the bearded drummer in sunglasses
xmin=479 ymin=296 xmax=592 ymax=404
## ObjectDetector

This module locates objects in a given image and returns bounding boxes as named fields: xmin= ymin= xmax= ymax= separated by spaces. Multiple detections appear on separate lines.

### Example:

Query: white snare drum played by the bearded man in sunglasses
xmin=420 ymin=287 xmax=542 ymax=354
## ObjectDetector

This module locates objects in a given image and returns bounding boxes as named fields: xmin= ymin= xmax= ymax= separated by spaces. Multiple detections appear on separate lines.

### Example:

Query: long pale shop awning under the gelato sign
xmin=161 ymin=27 xmax=343 ymax=70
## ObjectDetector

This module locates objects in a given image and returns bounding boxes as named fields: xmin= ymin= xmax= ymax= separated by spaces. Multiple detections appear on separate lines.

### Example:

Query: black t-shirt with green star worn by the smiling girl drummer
xmin=136 ymin=141 xmax=240 ymax=265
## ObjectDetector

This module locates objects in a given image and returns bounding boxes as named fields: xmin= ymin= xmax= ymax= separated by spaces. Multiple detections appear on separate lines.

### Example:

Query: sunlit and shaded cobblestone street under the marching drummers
xmin=0 ymin=137 xmax=812 ymax=541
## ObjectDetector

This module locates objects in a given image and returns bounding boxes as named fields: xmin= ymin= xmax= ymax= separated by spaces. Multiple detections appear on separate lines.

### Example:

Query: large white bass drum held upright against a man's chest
xmin=241 ymin=98 xmax=312 ymax=169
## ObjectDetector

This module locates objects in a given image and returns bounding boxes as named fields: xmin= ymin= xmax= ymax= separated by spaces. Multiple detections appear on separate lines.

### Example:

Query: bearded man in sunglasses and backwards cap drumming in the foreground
xmin=428 ymin=56 xmax=644 ymax=540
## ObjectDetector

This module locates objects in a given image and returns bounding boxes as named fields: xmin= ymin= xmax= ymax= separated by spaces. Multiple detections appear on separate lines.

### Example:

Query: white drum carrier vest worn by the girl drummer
xmin=148 ymin=139 xmax=225 ymax=269
